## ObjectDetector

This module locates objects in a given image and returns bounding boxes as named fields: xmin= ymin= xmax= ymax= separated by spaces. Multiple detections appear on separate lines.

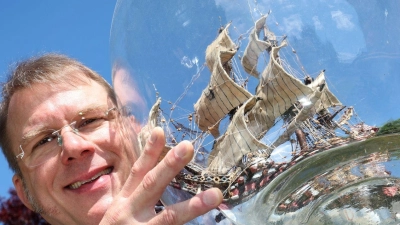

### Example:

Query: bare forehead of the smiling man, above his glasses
xmin=7 ymin=81 xmax=109 ymax=148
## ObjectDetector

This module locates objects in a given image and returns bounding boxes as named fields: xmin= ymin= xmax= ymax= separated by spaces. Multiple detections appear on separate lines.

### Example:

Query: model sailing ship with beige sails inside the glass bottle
xmin=139 ymin=15 xmax=377 ymax=205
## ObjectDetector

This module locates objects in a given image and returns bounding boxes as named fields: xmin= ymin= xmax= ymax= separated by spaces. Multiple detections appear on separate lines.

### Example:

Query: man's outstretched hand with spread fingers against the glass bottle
xmin=100 ymin=128 xmax=222 ymax=225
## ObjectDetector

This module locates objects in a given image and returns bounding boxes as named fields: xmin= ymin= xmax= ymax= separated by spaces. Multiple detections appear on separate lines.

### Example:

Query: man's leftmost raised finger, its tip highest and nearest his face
xmin=121 ymin=127 xmax=165 ymax=197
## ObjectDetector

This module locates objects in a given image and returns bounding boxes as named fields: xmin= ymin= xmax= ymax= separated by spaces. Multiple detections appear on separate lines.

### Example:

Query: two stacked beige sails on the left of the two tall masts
xmin=194 ymin=25 xmax=252 ymax=137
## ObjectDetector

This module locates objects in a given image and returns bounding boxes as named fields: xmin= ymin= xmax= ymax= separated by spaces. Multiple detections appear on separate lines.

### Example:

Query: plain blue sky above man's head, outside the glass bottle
xmin=0 ymin=0 xmax=116 ymax=197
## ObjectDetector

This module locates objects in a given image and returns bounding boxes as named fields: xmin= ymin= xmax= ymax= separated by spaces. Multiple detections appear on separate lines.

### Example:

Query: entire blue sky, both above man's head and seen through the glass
xmin=0 ymin=0 xmax=400 ymax=201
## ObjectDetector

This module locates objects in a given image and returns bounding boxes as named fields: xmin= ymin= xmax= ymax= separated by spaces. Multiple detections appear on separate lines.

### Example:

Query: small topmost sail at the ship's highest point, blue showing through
xmin=242 ymin=14 xmax=276 ymax=78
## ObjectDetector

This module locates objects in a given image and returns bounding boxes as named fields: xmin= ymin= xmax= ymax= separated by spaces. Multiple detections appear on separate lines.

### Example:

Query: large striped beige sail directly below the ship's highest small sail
xmin=248 ymin=40 xmax=314 ymax=135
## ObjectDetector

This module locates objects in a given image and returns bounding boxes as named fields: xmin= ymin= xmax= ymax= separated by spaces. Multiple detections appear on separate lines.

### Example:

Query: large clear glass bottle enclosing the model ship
xmin=111 ymin=0 xmax=400 ymax=224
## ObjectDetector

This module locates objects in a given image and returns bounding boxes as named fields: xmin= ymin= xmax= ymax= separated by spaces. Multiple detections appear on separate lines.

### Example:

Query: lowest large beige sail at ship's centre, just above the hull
xmin=208 ymin=97 xmax=272 ymax=174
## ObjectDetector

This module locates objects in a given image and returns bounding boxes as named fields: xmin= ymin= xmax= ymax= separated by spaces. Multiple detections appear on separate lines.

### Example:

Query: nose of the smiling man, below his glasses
xmin=60 ymin=127 xmax=95 ymax=164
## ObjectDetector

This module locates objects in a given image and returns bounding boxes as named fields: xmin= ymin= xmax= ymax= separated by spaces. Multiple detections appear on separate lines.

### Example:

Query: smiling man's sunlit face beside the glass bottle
xmin=7 ymin=76 xmax=134 ymax=224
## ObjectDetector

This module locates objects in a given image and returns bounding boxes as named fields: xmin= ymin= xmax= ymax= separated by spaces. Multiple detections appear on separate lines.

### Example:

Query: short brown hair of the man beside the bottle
xmin=0 ymin=53 xmax=117 ymax=176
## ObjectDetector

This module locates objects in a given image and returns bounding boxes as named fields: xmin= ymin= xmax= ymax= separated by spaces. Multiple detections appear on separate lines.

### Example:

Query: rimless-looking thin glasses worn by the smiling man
xmin=16 ymin=107 xmax=118 ymax=167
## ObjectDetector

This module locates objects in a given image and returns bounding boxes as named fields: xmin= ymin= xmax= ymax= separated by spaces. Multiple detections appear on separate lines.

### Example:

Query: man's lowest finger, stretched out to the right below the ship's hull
xmin=150 ymin=188 xmax=222 ymax=225
